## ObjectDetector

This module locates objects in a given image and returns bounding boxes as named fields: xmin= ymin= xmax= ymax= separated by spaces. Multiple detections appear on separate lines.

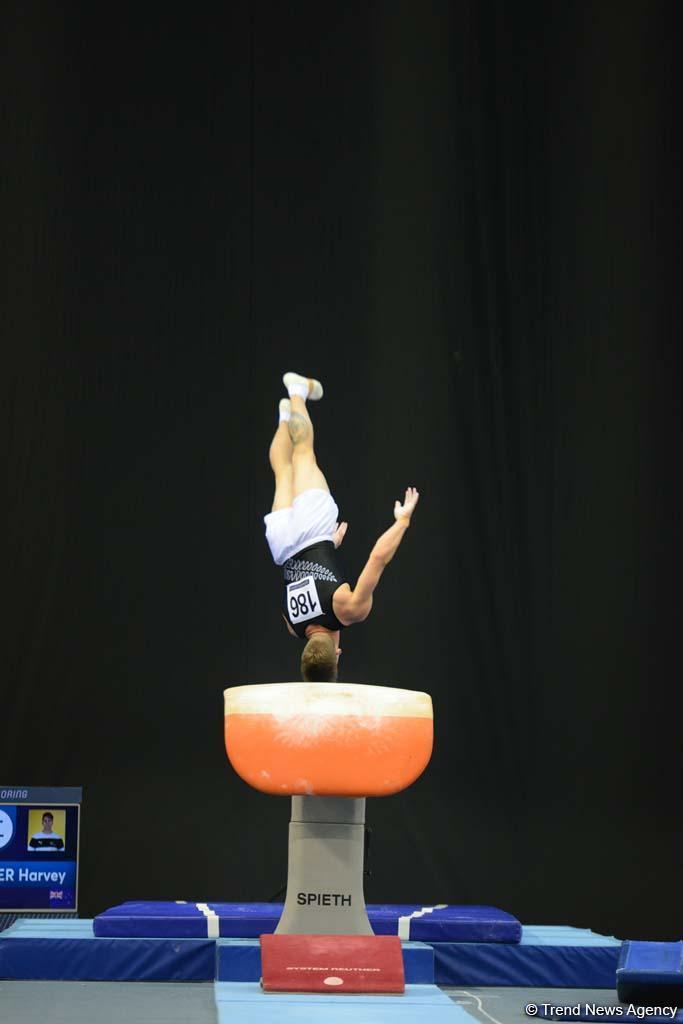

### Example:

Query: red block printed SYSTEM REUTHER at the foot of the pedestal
xmin=259 ymin=935 xmax=405 ymax=993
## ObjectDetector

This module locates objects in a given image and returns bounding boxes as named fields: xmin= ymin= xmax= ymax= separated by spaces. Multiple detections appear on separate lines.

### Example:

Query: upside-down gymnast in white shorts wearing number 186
xmin=264 ymin=373 xmax=420 ymax=683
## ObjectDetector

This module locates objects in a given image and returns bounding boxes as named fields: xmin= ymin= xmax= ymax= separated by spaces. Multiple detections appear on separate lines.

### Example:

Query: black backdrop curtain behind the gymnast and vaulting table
xmin=0 ymin=0 xmax=682 ymax=938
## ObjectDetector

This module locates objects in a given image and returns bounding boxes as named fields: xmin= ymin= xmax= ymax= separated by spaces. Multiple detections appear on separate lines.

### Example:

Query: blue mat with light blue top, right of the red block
xmin=430 ymin=925 xmax=622 ymax=988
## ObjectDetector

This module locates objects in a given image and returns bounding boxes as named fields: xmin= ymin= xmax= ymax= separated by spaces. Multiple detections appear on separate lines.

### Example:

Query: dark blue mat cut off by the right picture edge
xmin=616 ymin=941 xmax=683 ymax=1006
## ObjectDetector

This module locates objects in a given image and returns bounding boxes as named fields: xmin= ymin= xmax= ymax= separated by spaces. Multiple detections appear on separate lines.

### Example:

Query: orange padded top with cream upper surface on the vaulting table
xmin=224 ymin=683 xmax=433 ymax=797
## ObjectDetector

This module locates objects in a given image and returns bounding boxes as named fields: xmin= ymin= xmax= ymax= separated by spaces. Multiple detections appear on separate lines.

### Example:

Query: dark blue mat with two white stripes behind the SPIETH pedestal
xmin=94 ymin=900 xmax=521 ymax=942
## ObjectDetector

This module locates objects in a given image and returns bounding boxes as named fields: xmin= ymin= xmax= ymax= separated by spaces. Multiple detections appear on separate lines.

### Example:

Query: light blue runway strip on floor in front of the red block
xmin=215 ymin=982 xmax=473 ymax=1024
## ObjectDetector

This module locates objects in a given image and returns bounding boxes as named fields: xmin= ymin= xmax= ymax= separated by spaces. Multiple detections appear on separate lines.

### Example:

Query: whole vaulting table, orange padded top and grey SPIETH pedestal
xmin=224 ymin=683 xmax=433 ymax=935
